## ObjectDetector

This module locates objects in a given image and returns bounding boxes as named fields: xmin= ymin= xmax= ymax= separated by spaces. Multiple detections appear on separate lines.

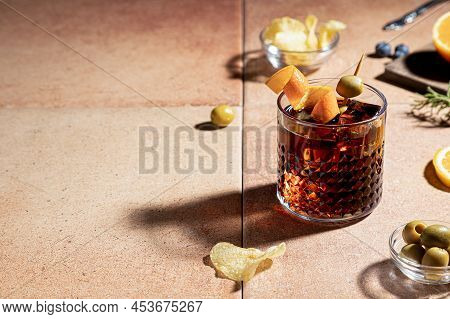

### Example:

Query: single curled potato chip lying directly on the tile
xmin=209 ymin=242 xmax=286 ymax=282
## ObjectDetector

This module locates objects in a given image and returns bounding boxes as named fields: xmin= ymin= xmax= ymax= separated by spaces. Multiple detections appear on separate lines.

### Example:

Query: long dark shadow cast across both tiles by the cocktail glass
xmin=127 ymin=184 xmax=332 ymax=256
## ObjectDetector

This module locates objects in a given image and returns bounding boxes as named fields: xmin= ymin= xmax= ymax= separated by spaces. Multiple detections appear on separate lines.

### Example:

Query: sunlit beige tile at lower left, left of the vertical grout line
xmin=0 ymin=107 xmax=241 ymax=298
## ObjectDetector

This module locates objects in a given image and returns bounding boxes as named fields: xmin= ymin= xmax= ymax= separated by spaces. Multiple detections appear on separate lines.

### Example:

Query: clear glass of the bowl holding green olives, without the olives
xmin=389 ymin=220 xmax=450 ymax=285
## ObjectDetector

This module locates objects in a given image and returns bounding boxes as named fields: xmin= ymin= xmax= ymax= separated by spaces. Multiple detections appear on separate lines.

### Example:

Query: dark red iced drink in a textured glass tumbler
xmin=277 ymin=81 xmax=386 ymax=222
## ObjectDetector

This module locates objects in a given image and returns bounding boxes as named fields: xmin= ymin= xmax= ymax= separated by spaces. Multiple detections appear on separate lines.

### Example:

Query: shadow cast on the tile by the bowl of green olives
xmin=358 ymin=259 xmax=450 ymax=299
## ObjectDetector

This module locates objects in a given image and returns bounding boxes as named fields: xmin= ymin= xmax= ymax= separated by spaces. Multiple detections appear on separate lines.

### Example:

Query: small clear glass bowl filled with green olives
xmin=389 ymin=220 xmax=450 ymax=285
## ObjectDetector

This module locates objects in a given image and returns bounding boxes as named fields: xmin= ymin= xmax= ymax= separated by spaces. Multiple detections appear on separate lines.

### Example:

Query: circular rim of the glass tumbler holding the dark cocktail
xmin=277 ymin=78 xmax=387 ymax=128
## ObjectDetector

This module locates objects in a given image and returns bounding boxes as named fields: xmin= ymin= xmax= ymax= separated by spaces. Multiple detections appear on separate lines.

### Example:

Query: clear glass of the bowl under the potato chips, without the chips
xmin=259 ymin=28 xmax=339 ymax=73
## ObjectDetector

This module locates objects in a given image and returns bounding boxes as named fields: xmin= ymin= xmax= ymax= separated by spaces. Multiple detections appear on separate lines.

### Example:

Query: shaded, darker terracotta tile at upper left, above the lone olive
xmin=0 ymin=0 xmax=242 ymax=107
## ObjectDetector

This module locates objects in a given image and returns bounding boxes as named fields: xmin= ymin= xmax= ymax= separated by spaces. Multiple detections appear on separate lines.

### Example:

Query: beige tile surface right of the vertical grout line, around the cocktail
xmin=244 ymin=0 xmax=450 ymax=298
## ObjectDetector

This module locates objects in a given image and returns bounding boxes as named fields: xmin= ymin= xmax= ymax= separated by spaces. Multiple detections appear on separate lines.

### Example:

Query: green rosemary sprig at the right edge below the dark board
xmin=412 ymin=82 xmax=450 ymax=125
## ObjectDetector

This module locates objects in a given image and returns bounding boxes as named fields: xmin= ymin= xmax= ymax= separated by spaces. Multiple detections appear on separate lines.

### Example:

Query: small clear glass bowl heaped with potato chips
xmin=260 ymin=15 xmax=346 ymax=73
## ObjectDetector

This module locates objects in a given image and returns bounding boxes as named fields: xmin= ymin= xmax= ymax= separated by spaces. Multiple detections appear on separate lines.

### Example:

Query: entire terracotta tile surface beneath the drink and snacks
xmin=0 ymin=0 xmax=450 ymax=298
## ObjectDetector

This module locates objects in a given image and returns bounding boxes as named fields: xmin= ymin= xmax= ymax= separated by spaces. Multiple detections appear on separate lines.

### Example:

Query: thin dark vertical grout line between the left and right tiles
xmin=241 ymin=0 xmax=245 ymax=299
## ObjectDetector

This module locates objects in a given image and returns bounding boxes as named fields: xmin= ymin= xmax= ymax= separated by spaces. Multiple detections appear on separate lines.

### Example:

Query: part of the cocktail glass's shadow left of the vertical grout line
xmin=127 ymin=190 xmax=242 ymax=252
